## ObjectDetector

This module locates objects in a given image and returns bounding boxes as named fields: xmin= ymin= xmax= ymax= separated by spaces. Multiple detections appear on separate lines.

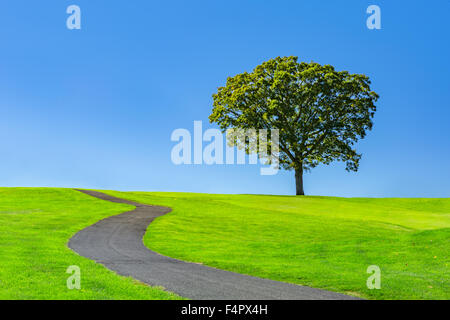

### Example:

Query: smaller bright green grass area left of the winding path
xmin=0 ymin=188 xmax=181 ymax=299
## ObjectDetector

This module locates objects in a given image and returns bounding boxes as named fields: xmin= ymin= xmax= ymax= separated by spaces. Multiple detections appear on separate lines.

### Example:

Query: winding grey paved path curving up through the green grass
xmin=68 ymin=190 xmax=355 ymax=300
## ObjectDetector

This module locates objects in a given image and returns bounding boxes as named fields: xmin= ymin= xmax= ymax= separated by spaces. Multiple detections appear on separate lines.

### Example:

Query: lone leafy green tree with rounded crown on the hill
xmin=209 ymin=57 xmax=378 ymax=195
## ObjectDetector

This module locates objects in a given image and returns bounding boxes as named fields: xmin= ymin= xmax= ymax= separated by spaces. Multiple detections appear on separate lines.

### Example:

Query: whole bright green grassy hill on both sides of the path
xmin=0 ymin=188 xmax=450 ymax=299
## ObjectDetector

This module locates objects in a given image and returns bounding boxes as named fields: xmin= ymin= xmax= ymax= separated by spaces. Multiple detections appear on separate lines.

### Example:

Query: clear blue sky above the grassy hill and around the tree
xmin=0 ymin=0 xmax=450 ymax=197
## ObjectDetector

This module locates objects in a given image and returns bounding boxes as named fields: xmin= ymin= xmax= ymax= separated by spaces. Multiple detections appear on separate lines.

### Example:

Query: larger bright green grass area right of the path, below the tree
xmin=102 ymin=191 xmax=450 ymax=299
